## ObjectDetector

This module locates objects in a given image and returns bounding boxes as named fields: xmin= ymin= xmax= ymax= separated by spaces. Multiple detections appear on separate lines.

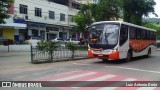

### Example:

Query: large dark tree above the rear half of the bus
xmin=122 ymin=0 xmax=156 ymax=25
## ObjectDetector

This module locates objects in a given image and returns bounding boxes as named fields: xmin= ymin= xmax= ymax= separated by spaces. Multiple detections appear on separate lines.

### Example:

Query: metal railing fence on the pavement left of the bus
xmin=31 ymin=46 xmax=88 ymax=63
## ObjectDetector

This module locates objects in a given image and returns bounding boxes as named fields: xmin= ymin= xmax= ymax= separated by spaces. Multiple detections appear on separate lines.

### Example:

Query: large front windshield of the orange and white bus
xmin=89 ymin=23 xmax=120 ymax=49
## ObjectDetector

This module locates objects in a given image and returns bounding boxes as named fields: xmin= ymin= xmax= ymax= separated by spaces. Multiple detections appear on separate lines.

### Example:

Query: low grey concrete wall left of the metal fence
xmin=0 ymin=45 xmax=31 ymax=52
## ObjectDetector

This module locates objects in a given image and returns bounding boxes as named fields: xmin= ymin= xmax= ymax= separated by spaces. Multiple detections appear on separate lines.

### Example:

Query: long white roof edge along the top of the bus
xmin=92 ymin=21 xmax=156 ymax=31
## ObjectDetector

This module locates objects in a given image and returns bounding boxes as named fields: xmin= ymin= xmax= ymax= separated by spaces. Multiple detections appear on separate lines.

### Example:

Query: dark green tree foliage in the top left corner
xmin=0 ymin=0 xmax=14 ymax=24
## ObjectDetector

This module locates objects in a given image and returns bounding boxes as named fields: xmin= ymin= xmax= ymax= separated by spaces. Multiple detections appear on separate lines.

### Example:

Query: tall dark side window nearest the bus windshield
xmin=120 ymin=24 xmax=128 ymax=46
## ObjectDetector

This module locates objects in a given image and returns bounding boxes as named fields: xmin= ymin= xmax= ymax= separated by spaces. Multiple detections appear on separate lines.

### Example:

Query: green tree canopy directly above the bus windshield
xmin=91 ymin=0 xmax=121 ymax=21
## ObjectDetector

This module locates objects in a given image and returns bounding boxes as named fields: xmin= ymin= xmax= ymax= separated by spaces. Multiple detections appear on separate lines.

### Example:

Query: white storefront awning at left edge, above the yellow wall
xmin=0 ymin=23 xmax=27 ymax=29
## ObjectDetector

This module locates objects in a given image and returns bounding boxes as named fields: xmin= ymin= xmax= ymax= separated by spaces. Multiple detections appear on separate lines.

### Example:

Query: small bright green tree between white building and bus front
xmin=73 ymin=3 xmax=93 ymax=38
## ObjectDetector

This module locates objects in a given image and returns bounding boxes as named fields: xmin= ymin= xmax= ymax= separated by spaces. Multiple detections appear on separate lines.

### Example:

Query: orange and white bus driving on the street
xmin=88 ymin=21 xmax=156 ymax=61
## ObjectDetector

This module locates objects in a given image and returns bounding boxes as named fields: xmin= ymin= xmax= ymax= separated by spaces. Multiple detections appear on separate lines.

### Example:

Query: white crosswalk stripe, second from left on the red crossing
xmin=72 ymin=74 xmax=115 ymax=88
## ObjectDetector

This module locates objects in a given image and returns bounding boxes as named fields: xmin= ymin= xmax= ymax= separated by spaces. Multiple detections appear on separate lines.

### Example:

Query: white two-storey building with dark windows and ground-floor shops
xmin=0 ymin=0 xmax=79 ymax=42
